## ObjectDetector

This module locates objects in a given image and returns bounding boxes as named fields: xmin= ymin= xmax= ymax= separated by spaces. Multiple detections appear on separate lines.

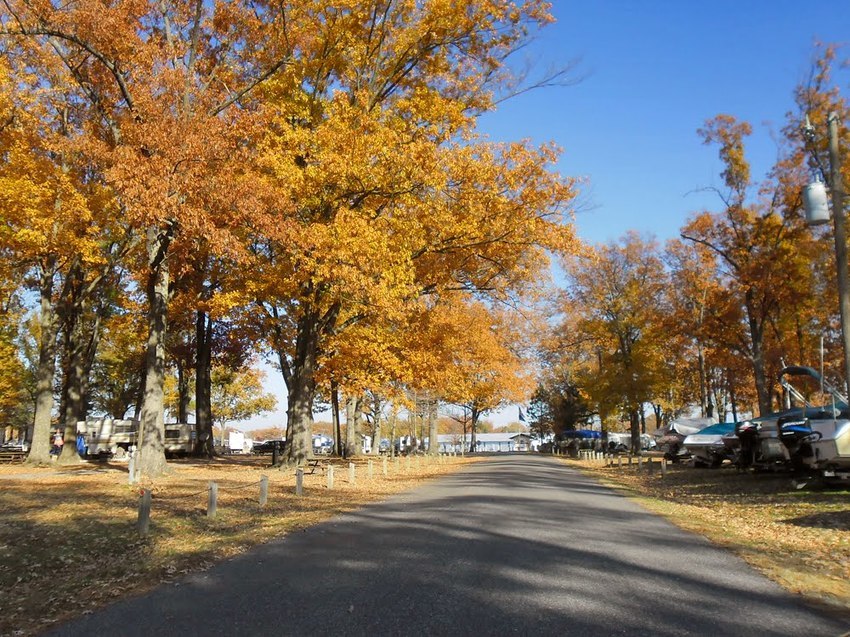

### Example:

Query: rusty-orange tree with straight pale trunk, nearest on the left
xmin=2 ymin=0 xmax=301 ymax=475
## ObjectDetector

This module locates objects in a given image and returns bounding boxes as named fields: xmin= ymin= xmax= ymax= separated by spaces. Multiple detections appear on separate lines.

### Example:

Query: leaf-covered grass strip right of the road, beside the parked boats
xmin=565 ymin=460 xmax=850 ymax=620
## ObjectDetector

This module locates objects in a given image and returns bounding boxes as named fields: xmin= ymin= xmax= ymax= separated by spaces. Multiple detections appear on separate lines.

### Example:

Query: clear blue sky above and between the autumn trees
xmin=242 ymin=0 xmax=850 ymax=428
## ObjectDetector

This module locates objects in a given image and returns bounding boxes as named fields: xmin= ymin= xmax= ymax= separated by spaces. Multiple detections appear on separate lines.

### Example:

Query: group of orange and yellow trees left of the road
xmin=0 ymin=0 xmax=577 ymax=476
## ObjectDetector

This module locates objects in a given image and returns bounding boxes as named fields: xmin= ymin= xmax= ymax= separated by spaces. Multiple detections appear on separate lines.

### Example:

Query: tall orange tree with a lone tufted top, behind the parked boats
xmin=682 ymin=115 xmax=812 ymax=414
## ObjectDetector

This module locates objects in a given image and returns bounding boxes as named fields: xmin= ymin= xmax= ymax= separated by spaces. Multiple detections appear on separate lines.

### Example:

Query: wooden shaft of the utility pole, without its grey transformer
xmin=828 ymin=111 xmax=850 ymax=394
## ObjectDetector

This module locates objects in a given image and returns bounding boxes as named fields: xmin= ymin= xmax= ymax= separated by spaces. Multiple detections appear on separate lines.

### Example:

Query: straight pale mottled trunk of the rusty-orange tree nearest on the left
xmin=137 ymin=228 xmax=171 ymax=478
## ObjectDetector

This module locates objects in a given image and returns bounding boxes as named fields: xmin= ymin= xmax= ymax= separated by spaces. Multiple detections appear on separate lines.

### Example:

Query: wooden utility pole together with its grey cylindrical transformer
xmin=803 ymin=112 xmax=850 ymax=393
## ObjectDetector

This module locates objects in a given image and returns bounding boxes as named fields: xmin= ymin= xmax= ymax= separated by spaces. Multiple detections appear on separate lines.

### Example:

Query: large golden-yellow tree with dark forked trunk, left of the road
xmin=245 ymin=0 xmax=573 ymax=462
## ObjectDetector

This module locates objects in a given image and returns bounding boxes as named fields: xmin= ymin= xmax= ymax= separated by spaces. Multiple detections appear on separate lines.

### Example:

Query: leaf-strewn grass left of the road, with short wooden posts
xmin=0 ymin=456 xmax=473 ymax=635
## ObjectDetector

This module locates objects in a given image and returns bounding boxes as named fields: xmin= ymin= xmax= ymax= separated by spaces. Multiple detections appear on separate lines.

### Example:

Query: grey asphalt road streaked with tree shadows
xmin=53 ymin=455 xmax=850 ymax=637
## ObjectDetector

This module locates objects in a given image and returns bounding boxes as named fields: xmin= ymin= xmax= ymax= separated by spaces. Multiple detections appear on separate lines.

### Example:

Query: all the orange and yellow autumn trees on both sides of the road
xmin=0 ymin=0 xmax=850 ymax=476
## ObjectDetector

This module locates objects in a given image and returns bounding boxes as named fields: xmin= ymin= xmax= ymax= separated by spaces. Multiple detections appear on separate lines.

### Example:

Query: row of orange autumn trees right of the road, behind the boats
xmin=530 ymin=47 xmax=850 ymax=450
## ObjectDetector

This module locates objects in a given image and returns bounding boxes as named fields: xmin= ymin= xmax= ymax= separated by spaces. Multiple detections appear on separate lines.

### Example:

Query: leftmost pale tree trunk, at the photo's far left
xmin=27 ymin=259 xmax=57 ymax=464
